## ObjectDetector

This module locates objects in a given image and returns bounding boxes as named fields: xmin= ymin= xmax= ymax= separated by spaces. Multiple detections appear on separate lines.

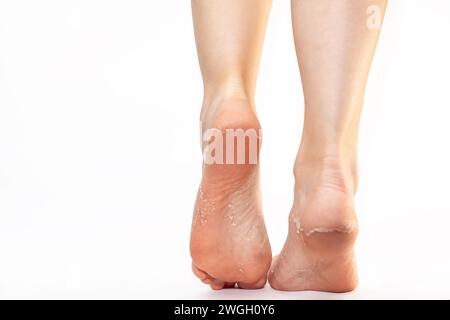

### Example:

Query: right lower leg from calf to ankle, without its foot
xmin=292 ymin=0 xmax=387 ymax=192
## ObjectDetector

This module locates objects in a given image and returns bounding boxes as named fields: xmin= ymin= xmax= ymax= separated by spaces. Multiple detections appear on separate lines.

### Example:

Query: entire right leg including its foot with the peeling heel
xmin=271 ymin=0 xmax=387 ymax=291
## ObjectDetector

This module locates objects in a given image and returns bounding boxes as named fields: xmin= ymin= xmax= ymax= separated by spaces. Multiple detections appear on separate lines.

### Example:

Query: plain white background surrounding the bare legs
xmin=0 ymin=0 xmax=450 ymax=299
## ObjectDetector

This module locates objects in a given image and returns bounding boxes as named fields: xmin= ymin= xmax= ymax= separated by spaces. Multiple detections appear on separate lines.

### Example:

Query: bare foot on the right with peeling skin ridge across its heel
xmin=269 ymin=157 xmax=358 ymax=292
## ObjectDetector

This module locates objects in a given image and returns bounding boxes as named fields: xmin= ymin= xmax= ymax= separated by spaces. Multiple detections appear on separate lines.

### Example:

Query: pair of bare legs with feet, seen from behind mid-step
xmin=191 ymin=0 xmax=387 ymax=292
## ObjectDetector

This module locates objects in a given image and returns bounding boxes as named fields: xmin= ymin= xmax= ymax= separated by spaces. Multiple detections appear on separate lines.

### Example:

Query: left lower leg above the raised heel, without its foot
xmin=192 ymin=0 xmax=272 ymax=120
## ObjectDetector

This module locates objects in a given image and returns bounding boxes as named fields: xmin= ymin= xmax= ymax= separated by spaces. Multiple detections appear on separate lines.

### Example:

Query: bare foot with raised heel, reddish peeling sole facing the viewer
xmin=190 ymin=99 xmax=272 ymax=290
